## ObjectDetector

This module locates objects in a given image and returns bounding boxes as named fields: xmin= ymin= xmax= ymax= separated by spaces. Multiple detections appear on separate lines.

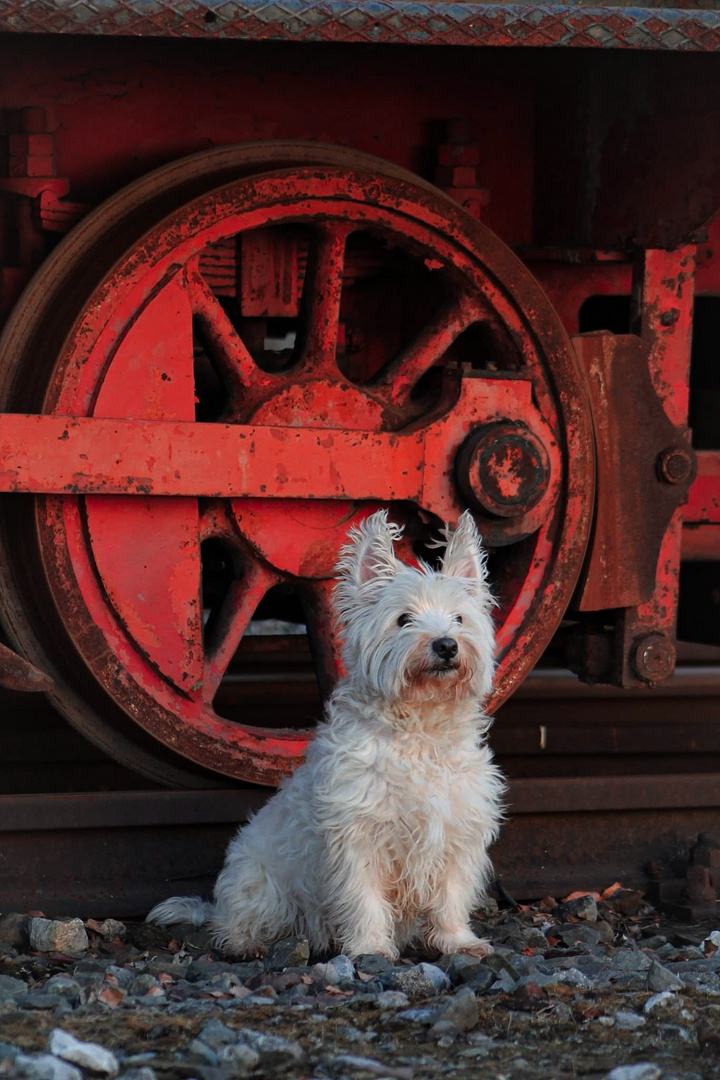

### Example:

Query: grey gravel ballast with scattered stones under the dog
xmin=0 ymin=890 xmax=720 ymax=1080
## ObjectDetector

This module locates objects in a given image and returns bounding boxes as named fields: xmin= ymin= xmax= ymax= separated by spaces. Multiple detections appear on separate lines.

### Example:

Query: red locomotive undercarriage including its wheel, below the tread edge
xmin=0 ymin=35 xmax=720 ymax=812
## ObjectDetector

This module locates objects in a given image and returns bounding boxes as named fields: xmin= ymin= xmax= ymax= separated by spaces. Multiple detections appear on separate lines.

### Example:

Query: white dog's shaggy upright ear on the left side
xmin=336 ymin=510 xmax=403 ymax=608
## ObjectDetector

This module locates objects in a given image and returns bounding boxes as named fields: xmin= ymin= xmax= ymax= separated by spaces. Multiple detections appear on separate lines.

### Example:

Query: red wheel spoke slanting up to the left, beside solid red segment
xmin=186 ymin=264 xmax=269 ymax=406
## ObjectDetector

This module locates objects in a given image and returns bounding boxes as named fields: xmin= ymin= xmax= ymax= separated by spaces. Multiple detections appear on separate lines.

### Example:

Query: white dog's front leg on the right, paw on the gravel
xmin=426 ymin=852 xmax=493 ymax=957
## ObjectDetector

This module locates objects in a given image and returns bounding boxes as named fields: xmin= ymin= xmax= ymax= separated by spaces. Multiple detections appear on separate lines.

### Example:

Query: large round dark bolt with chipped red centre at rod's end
xmin=456 ymin=420 xmax=549 ymax=517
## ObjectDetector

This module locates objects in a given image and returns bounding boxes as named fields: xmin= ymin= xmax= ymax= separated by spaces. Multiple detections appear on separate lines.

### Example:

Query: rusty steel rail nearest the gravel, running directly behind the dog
xmin=0 ymin=777 xmax=720 ymax=917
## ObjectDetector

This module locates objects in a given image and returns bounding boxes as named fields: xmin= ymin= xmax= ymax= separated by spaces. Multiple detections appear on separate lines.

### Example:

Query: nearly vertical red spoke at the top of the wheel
xmin=299 ymin=222 xmax=351 ymax=377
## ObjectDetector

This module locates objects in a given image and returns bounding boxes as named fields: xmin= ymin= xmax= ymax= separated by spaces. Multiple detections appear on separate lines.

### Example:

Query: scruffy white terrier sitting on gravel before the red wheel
xmin=148 ymin=511 xmax=504 ymax=959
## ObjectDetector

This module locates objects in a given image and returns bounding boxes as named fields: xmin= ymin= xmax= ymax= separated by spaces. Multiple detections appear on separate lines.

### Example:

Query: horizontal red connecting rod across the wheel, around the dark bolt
xmin=0 ymin=378 xmax=562 ymax=509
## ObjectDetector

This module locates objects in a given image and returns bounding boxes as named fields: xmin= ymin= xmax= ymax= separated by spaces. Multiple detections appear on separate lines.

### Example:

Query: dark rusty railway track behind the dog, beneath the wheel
xmin=0 ymin=638 xmax=720 ymax=917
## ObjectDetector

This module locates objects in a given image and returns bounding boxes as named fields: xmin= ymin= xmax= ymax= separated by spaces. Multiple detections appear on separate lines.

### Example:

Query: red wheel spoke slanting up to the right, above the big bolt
xmin=372 ymin=295 xmax=484 ymax=407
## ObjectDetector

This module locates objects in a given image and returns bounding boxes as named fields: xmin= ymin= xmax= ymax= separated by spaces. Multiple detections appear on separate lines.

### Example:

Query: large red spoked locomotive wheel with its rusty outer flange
xmin=0 ymin=144 xmax=593 ymax=784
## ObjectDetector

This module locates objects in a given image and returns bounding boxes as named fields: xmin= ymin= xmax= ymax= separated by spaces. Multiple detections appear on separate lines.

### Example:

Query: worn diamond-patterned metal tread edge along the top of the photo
xmin=0 ymin=0 xmax=720 ymax=52
